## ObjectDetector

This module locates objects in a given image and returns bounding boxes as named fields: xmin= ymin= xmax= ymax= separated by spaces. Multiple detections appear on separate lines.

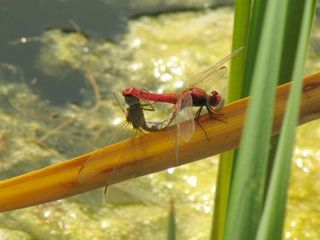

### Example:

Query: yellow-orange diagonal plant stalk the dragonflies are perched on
xmin=0 ymin=72 xmax=320 ymax=212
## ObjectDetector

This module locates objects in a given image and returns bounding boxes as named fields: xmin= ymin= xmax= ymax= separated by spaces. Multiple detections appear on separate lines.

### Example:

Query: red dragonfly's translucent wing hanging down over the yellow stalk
xmin=177 ymin=93 xmax=195 ymax=142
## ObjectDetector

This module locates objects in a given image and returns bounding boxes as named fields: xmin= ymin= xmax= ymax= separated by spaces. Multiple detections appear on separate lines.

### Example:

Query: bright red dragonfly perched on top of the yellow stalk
xmin=122 ymin=48 xmax=243 ymax=159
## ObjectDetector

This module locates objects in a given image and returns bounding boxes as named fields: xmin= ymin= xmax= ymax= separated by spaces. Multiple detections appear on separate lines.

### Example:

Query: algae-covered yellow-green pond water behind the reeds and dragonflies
xmin=0 ymin=0 xmax=320 ymax=239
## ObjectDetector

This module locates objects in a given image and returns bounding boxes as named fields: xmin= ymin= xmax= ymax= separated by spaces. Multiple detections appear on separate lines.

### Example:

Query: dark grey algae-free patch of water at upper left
xmin=0 ymin=0 xmax=126 ymax=105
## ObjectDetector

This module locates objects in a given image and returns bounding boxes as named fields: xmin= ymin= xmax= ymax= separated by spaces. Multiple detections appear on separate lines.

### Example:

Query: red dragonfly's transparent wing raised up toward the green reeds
xmin=191 ymin=47 xmax=243 ymax=87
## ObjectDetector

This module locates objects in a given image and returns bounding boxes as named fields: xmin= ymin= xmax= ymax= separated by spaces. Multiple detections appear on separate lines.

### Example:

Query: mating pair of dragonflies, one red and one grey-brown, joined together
xmin=122 ymin=48 xmax=242 ymax=150
